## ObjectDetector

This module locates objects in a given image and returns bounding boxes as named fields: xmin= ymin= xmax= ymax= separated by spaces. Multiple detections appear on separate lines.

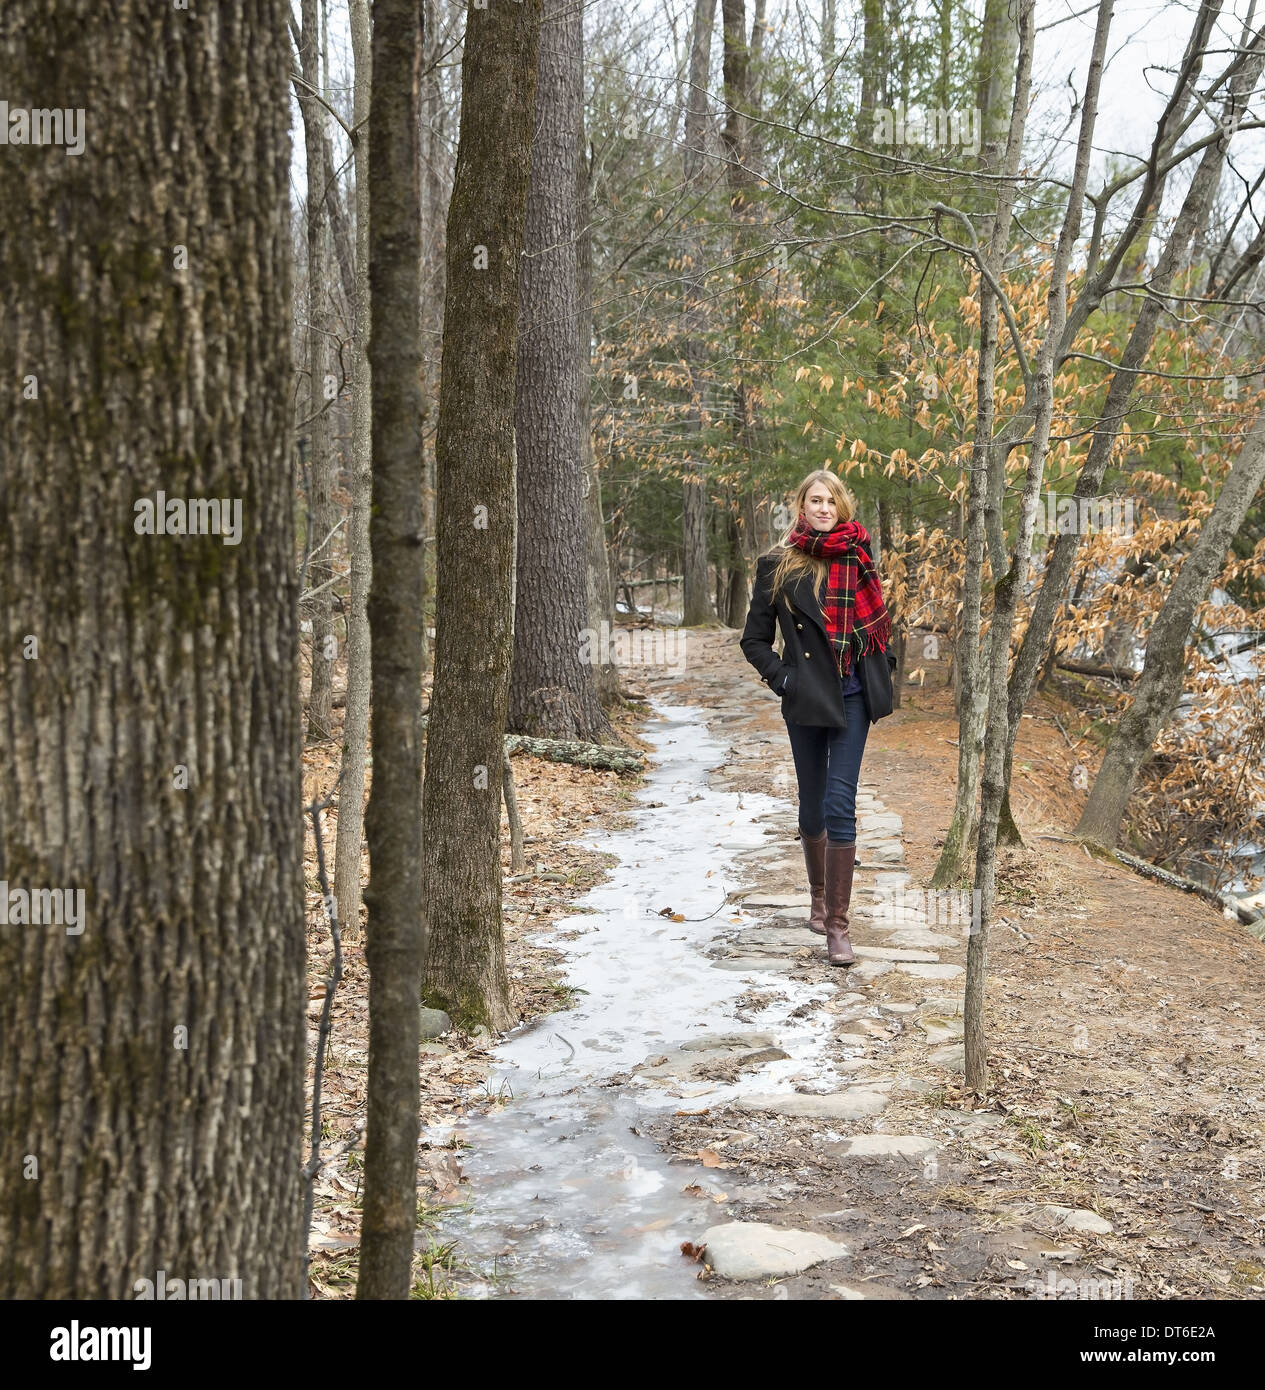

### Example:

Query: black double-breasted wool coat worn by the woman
xmin=740 ymin=553 xmax=897 ymax=728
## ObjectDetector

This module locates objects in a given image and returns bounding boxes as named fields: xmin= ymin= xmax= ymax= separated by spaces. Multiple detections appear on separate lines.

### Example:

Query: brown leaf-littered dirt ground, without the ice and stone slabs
xmin=306 ymin=630 xmax=1265 ymax=1298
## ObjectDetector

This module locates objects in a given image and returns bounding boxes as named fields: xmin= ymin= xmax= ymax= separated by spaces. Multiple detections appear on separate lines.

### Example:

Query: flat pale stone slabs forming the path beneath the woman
xmin=622 ymin=635 xmax=1107 ymax=1298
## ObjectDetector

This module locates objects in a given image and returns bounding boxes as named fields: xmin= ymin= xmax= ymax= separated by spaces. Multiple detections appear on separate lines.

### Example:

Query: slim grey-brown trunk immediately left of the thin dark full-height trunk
xmin=334 ymin=0 xmax=373 ymax=941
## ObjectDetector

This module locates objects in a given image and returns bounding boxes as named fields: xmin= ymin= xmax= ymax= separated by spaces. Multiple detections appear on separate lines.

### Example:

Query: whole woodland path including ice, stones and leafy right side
xmin=436 ymin=630 xmax=1265 ymax=1300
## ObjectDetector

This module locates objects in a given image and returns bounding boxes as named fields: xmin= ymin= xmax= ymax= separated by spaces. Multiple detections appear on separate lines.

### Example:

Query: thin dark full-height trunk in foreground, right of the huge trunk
xmin=356 ymin=0 xmax=428 ymax=1298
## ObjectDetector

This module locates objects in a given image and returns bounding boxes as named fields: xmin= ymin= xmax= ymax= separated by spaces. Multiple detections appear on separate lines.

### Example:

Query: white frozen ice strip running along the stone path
xmin=427 ymin=701 xmax=845 ymax=1298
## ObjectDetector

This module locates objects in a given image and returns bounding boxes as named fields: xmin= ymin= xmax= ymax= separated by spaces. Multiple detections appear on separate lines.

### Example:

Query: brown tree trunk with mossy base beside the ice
xmin=423 ymin=0 xmax=544 ymax=1029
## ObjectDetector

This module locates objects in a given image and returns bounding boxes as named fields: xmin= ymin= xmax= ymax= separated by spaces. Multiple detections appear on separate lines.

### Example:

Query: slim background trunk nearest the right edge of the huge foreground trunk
xmin=299 ymin=0 xmax=338 ymax=744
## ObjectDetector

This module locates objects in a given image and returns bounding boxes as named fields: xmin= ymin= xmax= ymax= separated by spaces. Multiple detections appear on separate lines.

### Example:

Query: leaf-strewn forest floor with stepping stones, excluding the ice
xmin=306 ymin=630 xmax=1265 ymax=1300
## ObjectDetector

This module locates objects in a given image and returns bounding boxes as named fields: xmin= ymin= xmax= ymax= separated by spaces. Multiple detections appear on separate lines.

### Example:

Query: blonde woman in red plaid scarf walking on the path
xmin=742 ymin=468 xmax=895 ymax=965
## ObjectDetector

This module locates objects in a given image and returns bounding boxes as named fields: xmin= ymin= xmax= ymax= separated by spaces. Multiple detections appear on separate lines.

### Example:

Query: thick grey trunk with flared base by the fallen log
xmin=508 ymin=0 xmax=614 ymax=745
